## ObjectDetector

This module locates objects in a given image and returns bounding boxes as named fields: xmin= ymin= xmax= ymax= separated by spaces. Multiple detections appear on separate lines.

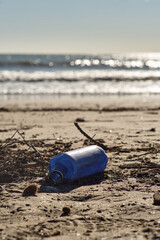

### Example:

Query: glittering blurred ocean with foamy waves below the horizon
xmin=0 ymin=53 xmax=160 ymax=96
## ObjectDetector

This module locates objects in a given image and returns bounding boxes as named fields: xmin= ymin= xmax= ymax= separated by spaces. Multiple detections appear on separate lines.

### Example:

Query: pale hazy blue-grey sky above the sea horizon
xmin=0 ymin=0 xmax=160 ymax=54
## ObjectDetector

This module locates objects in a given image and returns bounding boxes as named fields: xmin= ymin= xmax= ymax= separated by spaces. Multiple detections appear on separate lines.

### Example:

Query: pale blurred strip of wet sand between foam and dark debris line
xmin=0 ymin=95 xmax=160 ymax=111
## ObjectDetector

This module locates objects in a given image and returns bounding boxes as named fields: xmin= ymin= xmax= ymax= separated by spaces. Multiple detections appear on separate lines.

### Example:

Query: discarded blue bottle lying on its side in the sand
xmin=49 ymin=145 xmax=108 ymax=184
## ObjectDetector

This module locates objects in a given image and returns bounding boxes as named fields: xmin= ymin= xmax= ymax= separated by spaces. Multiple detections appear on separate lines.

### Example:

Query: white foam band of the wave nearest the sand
xmin=0 ymin=80 xmax=160 ymax=95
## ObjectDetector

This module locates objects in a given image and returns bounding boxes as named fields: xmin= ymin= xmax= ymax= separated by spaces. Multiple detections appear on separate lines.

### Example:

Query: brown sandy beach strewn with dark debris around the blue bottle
xmin=0 ymin=96 xmax=160 ymax=240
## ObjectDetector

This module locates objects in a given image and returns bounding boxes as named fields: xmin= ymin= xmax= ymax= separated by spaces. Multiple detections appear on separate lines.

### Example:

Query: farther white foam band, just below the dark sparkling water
xmin=0 ymin=70 xmax=160 ymax=82
